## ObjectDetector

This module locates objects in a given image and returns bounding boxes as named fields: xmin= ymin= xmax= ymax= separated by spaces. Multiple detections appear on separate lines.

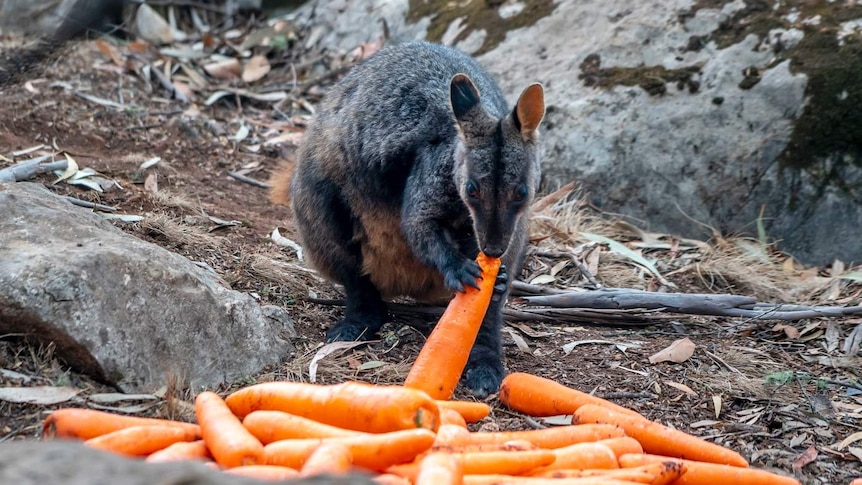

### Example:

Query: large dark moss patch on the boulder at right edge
xmin=680 ymin=0 xmax=862 ymax=194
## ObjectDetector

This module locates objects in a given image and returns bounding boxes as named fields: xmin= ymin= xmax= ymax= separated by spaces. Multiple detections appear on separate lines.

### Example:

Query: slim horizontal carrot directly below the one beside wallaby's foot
xmin=437 ymin=424 xmax=625 ymax=448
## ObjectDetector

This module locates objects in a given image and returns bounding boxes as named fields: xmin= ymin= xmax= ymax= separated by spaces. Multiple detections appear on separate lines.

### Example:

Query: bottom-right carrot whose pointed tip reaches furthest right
xmin=619 ymin=454 xmax=799 ymax=485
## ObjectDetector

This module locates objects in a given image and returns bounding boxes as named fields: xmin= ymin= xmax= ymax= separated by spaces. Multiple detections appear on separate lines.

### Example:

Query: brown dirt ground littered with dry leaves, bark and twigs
xmin=0 ymin=27 xmax=862 ymax=484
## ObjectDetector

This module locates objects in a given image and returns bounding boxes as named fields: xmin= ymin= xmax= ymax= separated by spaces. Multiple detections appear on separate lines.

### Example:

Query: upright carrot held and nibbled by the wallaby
xmin=404 ymin=253 xmax=500 ymax=399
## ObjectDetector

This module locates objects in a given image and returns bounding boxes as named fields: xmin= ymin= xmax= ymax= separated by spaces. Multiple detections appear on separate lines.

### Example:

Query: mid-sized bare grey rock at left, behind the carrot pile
xmin=0 ymin=182 xmax=294 ymax=392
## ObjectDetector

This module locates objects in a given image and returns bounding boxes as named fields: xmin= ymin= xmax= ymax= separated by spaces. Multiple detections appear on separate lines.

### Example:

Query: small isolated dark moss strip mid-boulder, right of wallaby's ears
xmin=578 ymin=54 xmax=700 ymax=96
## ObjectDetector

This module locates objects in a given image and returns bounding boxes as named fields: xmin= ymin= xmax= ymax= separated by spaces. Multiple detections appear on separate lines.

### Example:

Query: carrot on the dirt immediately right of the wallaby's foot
xmin=500 ymin=372 xmax=642 ymax=417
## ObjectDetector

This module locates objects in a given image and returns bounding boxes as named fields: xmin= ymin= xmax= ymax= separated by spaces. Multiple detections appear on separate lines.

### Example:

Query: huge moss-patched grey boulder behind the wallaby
xmin=292 ymin=0 xmax=862 ymax=264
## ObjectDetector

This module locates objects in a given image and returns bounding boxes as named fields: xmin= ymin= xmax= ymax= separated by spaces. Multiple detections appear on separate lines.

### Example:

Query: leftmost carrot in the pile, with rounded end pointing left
xmin=42 ymin=408 xmax=200 ymax=440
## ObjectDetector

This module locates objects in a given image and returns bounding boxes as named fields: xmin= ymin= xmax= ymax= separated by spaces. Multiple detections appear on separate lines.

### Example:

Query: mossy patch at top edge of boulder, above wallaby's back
xmin=407 ymin=0 xmax=554 ymax=55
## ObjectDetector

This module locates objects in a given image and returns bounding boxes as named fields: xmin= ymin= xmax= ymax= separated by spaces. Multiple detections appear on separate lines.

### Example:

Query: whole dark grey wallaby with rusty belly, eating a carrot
xmin=271 ymin=41 xmax=545 ymax=396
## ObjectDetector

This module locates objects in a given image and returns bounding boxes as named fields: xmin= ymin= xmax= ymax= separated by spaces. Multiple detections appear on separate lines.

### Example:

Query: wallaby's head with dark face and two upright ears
xmin=449 ymin=74 xmax=545 ymax=257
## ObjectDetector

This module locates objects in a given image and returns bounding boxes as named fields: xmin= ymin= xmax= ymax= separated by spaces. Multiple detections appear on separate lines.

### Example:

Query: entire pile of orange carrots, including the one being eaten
xmin=37 ymin=255 xmax=799 ymax=485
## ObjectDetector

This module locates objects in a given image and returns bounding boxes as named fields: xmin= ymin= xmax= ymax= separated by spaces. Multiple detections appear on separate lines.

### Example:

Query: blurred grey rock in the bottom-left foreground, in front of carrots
xmin=0 ymin=441 xmax=374 ymax=485
